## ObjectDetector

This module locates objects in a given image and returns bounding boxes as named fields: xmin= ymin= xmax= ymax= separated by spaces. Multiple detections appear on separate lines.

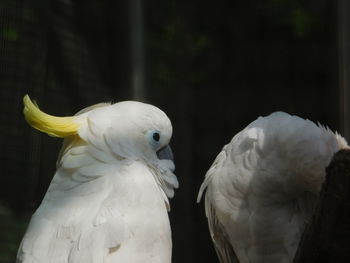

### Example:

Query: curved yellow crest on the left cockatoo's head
xmin=23 ymin=95 xmax=79 ymax=137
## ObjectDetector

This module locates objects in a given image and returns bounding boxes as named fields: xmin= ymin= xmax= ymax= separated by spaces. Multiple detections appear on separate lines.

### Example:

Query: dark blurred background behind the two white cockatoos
xmin=0 ymin=0 xmax=350 ymax=263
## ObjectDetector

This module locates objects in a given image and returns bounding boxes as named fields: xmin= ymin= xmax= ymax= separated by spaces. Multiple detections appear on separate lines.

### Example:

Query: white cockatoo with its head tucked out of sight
xmin=197 ymin=112 xmax=348 ymax=263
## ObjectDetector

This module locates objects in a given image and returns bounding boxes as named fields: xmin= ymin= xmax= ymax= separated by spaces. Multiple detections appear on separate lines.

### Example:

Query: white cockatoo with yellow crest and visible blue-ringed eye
xmin=17 ymin=95 xmax=178 ymax=263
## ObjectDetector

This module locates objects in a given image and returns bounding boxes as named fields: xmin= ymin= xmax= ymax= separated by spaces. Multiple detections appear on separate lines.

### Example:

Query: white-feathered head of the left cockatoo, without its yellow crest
xmin=75 ymin=101 xmax=172 ymax=161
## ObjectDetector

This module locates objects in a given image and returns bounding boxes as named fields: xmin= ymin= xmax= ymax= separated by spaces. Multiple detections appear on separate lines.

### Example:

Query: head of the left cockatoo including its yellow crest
xmin=23 ymin=95 xmax=177 ymax=197
